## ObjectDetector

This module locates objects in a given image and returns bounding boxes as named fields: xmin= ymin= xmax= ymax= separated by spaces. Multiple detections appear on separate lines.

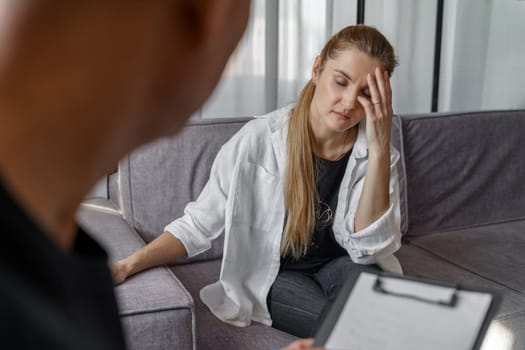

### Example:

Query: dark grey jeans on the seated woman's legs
xmin=267 ymin=256 xmax=376 ymax=338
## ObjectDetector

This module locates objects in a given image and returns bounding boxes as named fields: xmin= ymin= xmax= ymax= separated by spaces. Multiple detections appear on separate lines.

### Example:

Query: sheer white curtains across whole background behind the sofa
xmin=194 ymin=0 xmax=525 ymax=118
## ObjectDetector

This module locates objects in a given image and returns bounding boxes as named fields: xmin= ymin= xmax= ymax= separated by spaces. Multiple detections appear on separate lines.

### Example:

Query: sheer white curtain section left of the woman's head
xmin=195 ymin=0 xmax=334 ymax=118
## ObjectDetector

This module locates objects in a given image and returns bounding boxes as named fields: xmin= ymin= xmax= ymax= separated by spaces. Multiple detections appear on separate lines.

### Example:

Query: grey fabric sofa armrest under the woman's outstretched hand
xmin=77 ymin=198 xmax=195 ymax=349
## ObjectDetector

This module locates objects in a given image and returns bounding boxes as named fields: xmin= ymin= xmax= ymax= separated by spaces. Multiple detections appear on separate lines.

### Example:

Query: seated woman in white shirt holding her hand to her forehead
xmin=113 ymin=25 xmax=401 ymax=337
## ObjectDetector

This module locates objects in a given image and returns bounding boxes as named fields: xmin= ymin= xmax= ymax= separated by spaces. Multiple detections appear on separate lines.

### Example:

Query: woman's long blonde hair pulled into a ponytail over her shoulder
xmin=281 ymin=25 xmax=397 ymax=258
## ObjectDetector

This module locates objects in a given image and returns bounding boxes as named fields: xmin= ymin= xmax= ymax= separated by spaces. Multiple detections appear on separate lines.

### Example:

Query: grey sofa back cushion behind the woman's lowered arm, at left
xmin=116 ymin=118 xmax=250 ymax=262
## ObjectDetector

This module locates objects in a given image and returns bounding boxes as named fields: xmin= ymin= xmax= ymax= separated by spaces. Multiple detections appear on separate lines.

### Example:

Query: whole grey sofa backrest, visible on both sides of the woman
xmin=108 ymin=110 xmax=525 ymax=254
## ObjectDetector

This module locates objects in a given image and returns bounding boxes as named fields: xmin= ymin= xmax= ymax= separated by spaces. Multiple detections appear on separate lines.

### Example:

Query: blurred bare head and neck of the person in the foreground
xmin=0 ymin=0 xmax=250 ymax=245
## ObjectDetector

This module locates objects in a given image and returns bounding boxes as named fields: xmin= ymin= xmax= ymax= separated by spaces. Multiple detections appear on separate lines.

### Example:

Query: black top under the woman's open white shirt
xmin=281 ymin=150 xmax=352 ymax=274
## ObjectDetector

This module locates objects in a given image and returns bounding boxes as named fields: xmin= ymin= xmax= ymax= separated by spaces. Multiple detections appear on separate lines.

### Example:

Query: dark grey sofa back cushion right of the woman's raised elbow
xmin=398 ymin=110 xmax=525 ymax=235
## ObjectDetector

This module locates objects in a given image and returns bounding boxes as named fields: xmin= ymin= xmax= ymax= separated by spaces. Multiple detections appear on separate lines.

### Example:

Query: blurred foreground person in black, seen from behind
xmin=0 ymin=0 xmax=249 ymax=350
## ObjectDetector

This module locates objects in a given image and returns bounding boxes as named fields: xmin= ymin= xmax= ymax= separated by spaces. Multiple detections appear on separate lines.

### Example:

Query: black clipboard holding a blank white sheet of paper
xmin=314 ymin=268 xmax=501 ymax=350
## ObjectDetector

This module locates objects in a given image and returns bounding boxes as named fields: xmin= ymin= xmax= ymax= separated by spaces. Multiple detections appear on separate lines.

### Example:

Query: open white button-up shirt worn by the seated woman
xmin=165 ymin=106 xmax=401 ymax=327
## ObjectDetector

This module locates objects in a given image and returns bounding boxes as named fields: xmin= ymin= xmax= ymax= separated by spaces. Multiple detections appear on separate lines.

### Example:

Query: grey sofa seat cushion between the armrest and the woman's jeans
xmin=171 ymin=260 xmax=297 ymax=350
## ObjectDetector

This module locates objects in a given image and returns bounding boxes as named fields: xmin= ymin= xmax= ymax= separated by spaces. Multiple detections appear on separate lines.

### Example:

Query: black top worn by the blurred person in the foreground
xmin=0 ymin=181 xmax=125 ymax=350
